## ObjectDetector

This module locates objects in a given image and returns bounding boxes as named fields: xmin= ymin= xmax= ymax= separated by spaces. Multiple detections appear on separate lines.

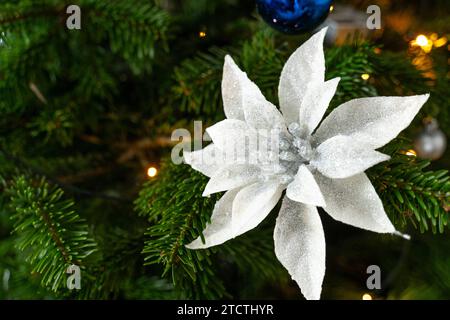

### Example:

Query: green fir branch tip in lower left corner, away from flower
xmin=6 ymin=176 xmax=96 ymax=291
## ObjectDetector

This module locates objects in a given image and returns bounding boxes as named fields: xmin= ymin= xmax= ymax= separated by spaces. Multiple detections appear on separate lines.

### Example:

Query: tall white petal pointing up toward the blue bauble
xmin=278 ymin=28 xmax=327 ymax=125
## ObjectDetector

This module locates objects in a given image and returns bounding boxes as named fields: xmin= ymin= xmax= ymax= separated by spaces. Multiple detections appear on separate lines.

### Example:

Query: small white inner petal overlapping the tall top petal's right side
xmin=299 ymin=78 xmax=341 ymax=137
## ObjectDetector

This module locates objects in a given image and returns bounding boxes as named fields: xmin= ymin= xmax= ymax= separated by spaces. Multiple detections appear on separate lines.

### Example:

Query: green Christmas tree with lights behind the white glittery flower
xmin=0 ymin=0 xmax=450 ymax=299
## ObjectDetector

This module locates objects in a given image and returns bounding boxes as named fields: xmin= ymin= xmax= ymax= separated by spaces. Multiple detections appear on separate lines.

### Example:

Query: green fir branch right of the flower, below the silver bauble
xmin=369 ymin=142 xmax=450 ymax=233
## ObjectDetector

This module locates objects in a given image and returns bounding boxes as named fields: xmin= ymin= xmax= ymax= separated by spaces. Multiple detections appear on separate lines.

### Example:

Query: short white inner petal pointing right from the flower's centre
xmin=311 ymin=136 xmax=390 ymax=178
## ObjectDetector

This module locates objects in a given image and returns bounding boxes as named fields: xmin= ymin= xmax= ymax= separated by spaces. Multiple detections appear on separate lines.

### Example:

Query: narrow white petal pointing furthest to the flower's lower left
xmin=186 ymin=189 xmax=241 ymax=249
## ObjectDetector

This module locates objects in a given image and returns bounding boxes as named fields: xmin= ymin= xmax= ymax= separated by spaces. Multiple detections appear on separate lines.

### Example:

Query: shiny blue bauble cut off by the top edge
xmin=256 ymin=0 xmax=332 ymax=34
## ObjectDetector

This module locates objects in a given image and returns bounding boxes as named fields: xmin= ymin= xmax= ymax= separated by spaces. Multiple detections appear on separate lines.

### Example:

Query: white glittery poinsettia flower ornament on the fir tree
xmin=184 ymin=29 xmax=429 ymax=299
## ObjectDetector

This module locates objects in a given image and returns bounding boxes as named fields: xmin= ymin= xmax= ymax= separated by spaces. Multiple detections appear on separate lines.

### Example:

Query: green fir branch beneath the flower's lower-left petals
xmin=136 ymin=164 xmax=225 ymax=299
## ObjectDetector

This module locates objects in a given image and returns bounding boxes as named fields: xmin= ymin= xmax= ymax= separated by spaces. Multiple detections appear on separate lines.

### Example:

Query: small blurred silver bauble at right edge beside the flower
xmin=414 ymin=119 xmax=447 ymax=160
